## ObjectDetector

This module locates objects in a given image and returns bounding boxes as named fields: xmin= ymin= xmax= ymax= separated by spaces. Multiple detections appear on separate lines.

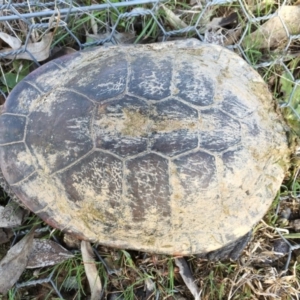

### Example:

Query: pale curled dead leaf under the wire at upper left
xmin=0 ymin=32 xmax=53 ymax=61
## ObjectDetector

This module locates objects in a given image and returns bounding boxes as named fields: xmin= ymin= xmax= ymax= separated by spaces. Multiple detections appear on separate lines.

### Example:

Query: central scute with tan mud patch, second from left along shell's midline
xmin=93 ymin=95 xmax=149 ymax=157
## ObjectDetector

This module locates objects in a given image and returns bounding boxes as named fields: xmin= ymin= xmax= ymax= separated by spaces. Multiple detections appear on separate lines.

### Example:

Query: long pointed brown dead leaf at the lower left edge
xmin=0 ymin=228 xmax=35 ymax=294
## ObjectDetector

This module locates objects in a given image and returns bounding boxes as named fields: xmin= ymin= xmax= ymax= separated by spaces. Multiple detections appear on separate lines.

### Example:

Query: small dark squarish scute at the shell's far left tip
xmin=0 ymin=114 xmax=26 ymax=145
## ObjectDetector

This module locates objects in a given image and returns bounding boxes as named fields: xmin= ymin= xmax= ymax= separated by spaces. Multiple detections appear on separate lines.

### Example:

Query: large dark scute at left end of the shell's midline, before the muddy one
xmin=26 ymin=91 xmax=94 ymax=173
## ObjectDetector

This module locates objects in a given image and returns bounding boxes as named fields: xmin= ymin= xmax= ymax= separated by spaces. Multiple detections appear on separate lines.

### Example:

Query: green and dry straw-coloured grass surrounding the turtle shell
xmin=0 ymin=1 xmax=300 ymax=300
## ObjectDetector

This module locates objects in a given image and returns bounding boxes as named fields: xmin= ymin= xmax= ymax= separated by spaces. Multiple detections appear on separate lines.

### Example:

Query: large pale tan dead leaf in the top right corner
xmin=242 ymin=5 xmax=300 ymax=48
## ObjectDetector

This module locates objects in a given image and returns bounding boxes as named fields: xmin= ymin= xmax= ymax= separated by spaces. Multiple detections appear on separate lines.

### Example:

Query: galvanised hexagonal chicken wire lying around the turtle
xmin=0 ymin=0 xmax=300 ymax=297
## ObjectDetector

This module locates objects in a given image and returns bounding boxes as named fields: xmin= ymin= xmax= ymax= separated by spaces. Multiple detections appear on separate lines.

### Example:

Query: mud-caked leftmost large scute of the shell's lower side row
xmin=57 ymin=151 xmax=123 ymax=226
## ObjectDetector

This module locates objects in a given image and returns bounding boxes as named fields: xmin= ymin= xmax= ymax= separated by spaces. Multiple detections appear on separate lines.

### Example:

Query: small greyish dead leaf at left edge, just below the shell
xmin=0 ymin=203 xmax=24 ymax=228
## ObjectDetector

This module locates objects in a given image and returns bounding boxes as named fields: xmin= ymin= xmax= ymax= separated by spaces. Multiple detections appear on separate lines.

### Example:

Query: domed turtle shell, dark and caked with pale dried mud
xmin=0 ymin=39 xmax=291 ymax=255
